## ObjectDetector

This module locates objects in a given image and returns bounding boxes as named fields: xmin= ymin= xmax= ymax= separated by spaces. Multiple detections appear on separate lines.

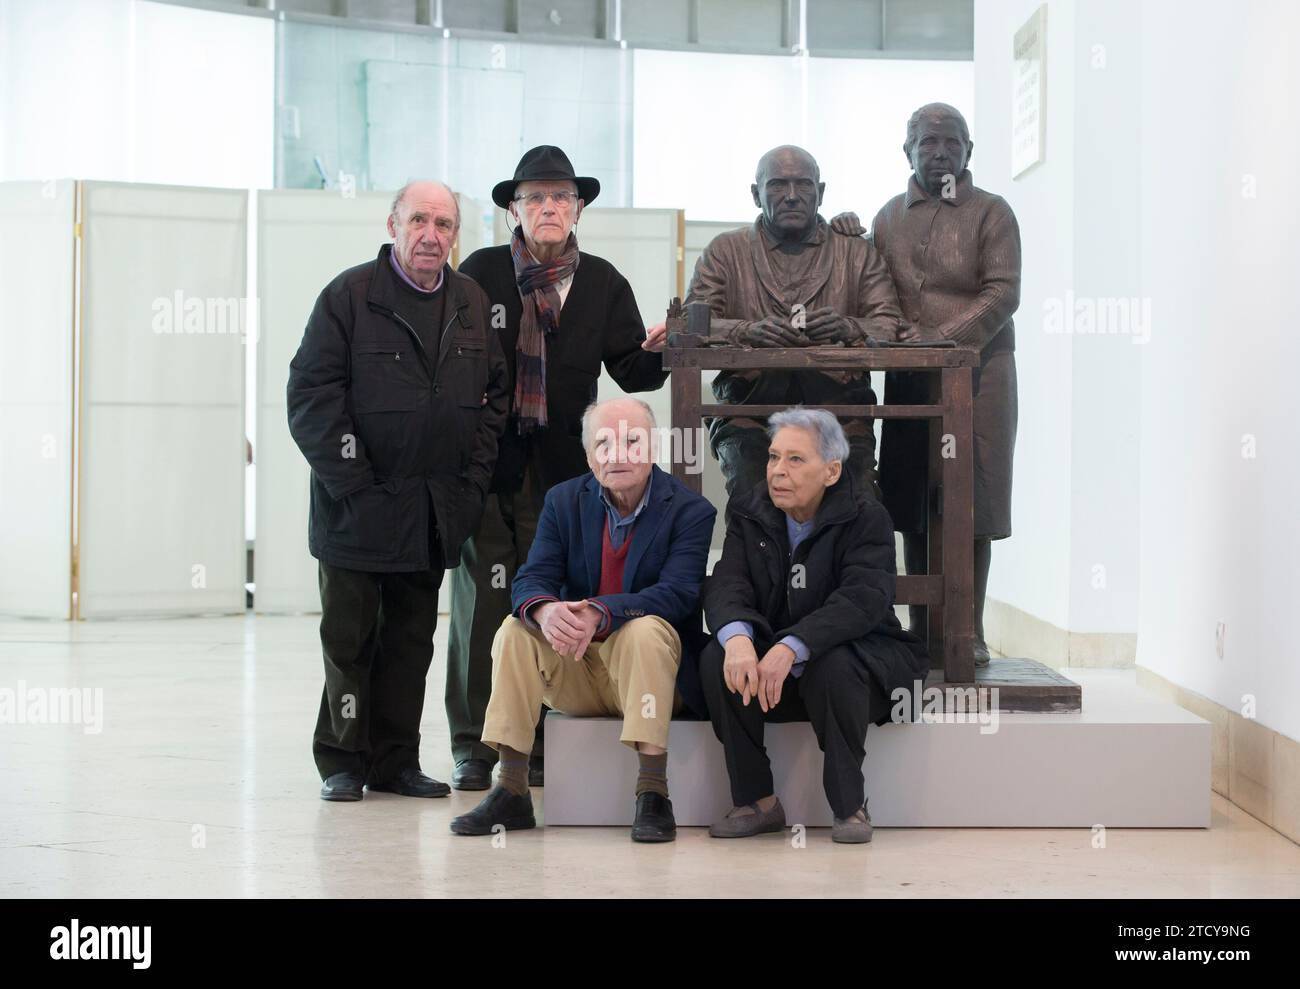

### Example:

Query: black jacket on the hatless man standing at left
xmin=287 ymin=244 xmax=510 ymax=573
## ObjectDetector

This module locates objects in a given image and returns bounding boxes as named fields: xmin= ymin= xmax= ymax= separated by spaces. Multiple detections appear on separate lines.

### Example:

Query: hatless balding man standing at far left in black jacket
xmin=289 ymin=182 xmax=508 ymax=801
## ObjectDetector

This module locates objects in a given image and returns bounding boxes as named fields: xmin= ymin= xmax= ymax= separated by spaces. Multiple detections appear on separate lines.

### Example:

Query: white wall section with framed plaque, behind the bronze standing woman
xmin=971 ymin=0 xmax=1149 ymax=647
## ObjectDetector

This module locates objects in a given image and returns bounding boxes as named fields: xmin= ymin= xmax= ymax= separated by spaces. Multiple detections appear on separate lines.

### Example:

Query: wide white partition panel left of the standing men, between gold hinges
xmin=79 ymin=182 xmax=248 ymax=617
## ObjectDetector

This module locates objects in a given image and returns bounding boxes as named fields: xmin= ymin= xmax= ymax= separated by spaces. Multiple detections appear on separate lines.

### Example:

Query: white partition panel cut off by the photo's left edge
xmin=0 ymin=181 xmax=75 ymax=619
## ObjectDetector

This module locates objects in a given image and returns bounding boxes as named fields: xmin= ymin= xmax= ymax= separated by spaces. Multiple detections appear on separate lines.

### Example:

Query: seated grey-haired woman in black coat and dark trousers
xmin=699 ymin=407 xmax=930 ymax=842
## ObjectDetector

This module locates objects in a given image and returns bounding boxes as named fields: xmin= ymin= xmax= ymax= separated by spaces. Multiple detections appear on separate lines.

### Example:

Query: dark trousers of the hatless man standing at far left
xmin=312 ymin=541 xmax=442 ymax=784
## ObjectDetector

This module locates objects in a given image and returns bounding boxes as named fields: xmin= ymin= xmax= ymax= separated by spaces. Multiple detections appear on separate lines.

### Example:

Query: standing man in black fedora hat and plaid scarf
xmin=446 ymin=144 xmax=668 ymax=790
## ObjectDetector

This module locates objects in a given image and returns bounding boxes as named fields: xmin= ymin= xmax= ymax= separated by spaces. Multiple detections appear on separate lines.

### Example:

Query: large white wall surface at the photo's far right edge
xmin=1138 ymin=0 xmax=1300 ymax=739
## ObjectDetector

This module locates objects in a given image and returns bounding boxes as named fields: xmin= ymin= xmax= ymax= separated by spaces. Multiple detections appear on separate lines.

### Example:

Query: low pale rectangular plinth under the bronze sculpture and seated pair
xmin=534 ymin=660 xmax=1210 ymax=828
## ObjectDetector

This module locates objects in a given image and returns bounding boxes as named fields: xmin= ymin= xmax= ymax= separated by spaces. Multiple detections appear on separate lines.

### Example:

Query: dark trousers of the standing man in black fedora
xmin=446 ymin=464 xmax=545 ymax=764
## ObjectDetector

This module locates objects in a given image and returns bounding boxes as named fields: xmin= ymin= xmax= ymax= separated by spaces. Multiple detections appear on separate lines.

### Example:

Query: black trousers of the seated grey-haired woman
xmin=699 ymin=638 xmax=889 ymax=817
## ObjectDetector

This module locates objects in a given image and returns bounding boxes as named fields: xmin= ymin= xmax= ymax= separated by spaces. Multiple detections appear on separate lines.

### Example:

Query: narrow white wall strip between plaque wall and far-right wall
xmin=1060 ymin=0 xmax=1144 ymax=636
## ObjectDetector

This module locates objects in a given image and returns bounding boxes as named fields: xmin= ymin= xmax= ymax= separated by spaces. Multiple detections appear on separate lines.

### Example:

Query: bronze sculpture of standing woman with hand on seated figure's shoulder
xmin=831 ymin=103 xmax=1021 ymax=665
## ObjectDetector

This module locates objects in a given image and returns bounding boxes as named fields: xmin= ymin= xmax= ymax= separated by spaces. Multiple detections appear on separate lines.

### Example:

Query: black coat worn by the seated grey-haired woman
xmin=703 ymin=473 xmax=930 ymax=712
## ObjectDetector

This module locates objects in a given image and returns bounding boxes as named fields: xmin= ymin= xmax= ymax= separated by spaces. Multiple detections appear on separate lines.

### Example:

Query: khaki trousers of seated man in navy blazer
xmin=482 ymin=615 xmax=681 ymax=752
